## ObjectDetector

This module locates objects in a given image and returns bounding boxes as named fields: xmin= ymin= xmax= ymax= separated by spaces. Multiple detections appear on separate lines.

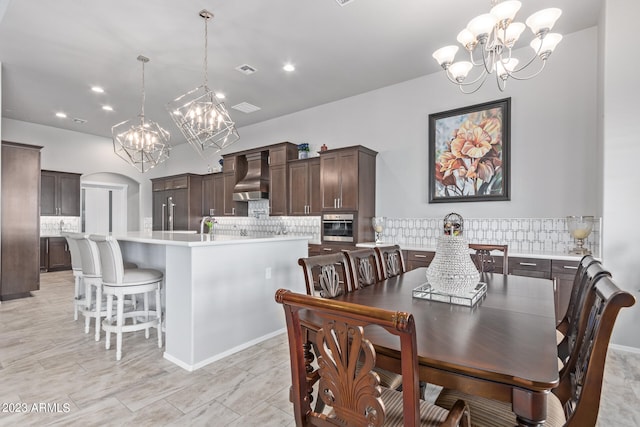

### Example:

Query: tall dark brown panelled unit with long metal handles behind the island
xmin=151 ymin=174 xmax=202 ymax=231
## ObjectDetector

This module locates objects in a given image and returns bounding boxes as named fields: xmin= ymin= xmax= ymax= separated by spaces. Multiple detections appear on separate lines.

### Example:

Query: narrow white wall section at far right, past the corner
xmin=603 ymin=0 xmax=640 ymax=348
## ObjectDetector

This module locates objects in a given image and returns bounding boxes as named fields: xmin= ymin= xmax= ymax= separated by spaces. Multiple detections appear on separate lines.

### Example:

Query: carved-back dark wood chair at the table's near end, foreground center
xmin=275 ymin=289 xmax=470 ymax=427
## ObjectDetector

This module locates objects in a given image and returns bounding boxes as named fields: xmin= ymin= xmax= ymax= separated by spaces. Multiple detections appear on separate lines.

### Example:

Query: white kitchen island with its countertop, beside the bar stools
xmin=114 ymin=231 xmax=309 ymax=371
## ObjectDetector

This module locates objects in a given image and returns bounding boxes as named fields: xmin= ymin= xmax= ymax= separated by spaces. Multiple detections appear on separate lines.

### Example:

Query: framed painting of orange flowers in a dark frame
xmin=429 ymin=98 xmax=511 ymax=203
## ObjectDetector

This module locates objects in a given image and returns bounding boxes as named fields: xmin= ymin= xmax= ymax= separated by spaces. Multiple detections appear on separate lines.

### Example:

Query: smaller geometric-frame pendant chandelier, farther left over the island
xmin=111 ymin=55 xmax=171 ymax=173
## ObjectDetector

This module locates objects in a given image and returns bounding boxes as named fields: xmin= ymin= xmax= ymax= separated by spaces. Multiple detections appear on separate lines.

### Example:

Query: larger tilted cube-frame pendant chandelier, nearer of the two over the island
xmin=167 ymin=10 xmax=240 ymax=158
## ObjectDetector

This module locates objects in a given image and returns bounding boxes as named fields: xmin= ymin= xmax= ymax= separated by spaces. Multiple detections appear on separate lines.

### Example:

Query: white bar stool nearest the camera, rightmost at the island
xmin=89 ymin=234 xmax=163 ymax=360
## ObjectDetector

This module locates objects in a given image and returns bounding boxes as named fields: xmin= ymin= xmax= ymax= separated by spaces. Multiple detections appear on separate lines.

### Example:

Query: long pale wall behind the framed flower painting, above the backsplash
xmin=237 ymin=28 xmax=601 ymax=218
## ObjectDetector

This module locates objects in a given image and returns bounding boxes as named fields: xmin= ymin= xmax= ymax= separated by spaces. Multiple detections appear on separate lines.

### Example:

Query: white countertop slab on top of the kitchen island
xmin=114 ymin=231 xmax=312 ymax=246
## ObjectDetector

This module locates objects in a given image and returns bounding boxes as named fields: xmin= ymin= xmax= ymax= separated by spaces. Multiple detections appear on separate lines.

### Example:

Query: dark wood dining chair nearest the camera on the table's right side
xmin=436 ymin=265 xmax=635 ymax=427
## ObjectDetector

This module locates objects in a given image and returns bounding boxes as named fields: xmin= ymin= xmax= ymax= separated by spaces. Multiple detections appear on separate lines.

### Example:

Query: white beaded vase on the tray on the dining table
xmin=427 ymin=236 xmax=480 ymax=295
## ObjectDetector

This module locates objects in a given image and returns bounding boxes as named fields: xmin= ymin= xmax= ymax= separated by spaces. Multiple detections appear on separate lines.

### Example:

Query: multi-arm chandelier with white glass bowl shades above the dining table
xmin=433 ymin=0 xmax=562 ymax=94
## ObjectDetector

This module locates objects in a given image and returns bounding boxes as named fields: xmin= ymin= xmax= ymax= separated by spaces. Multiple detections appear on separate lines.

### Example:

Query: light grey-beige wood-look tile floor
xmin=0 ymin=272 xmax=640 ymax=427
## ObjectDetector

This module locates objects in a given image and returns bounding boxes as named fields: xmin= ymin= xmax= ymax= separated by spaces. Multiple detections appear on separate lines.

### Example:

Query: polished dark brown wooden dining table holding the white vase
xmin=301 ymin=268 xmax=559 ymax=426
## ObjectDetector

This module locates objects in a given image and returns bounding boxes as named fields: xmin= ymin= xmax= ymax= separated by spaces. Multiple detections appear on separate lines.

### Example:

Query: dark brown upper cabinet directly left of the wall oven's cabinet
xmin=289 ymin=158 xmax=322 ymax=216
